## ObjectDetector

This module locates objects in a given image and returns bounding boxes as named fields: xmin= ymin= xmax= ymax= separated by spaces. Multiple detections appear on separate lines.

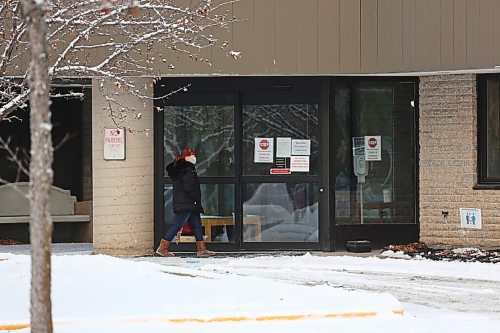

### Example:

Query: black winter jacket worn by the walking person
xmin=167 ymin=159 xmax=203 ymax=213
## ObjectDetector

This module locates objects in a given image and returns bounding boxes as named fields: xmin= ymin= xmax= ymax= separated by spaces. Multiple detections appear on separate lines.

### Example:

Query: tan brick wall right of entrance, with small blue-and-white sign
xmin=419 ymin=74 xmax=500 ymax=247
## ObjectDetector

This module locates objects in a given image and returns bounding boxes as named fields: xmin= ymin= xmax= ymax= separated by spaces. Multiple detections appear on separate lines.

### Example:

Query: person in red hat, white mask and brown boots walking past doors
xmin=156 ymin=148 xmax=215 ymax=257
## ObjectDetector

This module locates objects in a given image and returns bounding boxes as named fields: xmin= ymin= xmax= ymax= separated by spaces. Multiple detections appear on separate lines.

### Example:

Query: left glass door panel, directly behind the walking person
xmin=162 ymin=94 xmax=236 ymax=244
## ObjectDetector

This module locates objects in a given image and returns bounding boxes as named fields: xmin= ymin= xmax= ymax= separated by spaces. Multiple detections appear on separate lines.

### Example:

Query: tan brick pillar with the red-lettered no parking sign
xmin=92 ymin=78 xmax=154 ymax=255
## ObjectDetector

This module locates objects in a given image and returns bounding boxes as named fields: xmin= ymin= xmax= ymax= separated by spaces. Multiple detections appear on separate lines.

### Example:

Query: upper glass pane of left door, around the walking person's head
xmin=163 ymin=105 xmax=234 ymax=176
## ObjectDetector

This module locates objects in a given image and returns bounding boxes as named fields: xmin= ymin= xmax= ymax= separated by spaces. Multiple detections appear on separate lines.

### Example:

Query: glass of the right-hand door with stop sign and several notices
xmin=242 ymin=103 xmax=319 ymax=243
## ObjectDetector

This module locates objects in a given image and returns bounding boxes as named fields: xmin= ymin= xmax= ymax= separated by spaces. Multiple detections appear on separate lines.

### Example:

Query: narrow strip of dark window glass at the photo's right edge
xmin=486 ymin=79 xmax=500 ymax=182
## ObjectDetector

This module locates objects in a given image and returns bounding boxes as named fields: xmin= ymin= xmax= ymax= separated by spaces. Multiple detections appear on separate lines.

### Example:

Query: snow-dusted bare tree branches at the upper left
xmin=0 ymin=0 xmax=239 ymax=121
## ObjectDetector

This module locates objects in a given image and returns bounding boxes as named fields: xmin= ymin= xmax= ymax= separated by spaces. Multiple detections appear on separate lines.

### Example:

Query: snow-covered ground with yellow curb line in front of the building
xmin=0 ymin=244 xmax=500 ymax=333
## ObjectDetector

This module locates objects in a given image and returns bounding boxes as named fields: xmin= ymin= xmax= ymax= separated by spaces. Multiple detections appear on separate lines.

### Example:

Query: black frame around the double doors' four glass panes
xmin=154 ymin=77 xmax=331 ymax=252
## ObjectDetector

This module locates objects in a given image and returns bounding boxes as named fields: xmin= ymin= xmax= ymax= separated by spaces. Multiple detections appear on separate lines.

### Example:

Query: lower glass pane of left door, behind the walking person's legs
xmin=162 ymin=184 xmax=234 ymax=243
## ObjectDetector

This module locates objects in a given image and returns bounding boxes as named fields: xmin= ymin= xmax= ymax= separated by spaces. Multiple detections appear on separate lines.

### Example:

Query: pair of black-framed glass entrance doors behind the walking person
xmin=155 ymin=78 xmax=320 ymax=251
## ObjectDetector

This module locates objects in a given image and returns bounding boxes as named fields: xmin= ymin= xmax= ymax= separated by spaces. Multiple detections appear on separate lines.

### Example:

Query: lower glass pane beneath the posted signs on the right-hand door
xmin=243 ymin=183 xmax=319 ymax=242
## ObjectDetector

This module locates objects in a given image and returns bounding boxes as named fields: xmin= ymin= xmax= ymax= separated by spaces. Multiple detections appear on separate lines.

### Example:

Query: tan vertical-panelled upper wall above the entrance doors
xmin=158 ymin=0 xmax=500 ymax=75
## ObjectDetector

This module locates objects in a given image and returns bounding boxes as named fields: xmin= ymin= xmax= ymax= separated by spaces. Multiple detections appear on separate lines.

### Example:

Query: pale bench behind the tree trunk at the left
xmin=0 ymin=182 xmax=92 ymax=241
